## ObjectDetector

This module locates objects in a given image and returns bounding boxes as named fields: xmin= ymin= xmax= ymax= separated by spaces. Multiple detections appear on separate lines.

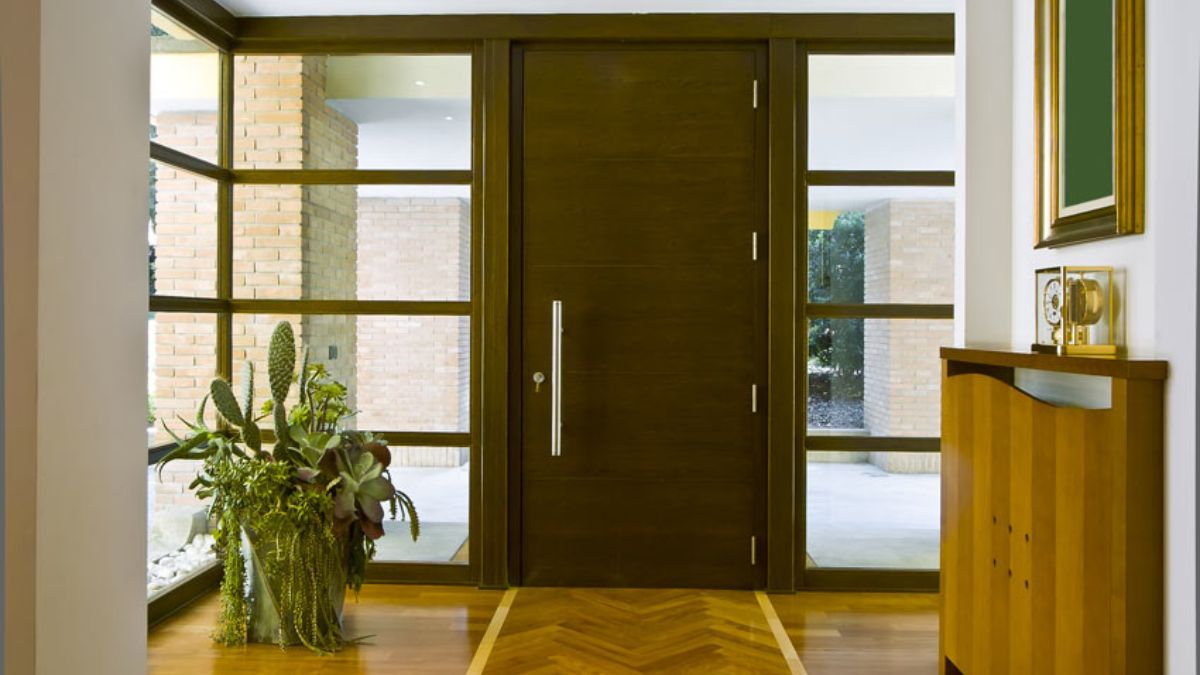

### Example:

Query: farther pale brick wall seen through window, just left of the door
xmin=358 ymin=197 xmax=470 ymax=466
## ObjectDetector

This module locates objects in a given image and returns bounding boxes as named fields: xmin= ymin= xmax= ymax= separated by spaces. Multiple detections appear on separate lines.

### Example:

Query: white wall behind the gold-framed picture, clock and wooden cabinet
xmin=1008 ymin=0 xmax=1200 ymax=673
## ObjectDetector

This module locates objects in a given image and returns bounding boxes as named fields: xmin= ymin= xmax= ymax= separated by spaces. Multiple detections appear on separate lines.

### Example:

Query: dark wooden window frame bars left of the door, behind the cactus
xmin=148 ymin=0 xmax=482 ymax=625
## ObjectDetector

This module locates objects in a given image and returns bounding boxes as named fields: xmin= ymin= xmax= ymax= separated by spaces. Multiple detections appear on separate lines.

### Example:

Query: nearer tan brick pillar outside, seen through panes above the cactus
xmin=234 ymin=56 xmax=358 ymax=415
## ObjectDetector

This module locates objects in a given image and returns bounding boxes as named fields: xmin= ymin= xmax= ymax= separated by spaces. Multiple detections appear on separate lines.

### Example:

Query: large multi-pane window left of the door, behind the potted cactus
xmin=146 ymin=8 xmax=479 ymax=604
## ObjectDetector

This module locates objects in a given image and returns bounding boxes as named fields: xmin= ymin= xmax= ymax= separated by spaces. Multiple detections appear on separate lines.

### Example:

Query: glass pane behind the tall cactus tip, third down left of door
xmin=233 ymin=315 xmax=470 ymax=432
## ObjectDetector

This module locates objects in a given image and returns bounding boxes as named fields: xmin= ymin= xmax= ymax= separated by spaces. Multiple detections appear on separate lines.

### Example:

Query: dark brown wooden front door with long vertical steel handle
xmin=515 ymin=44 xmax=766 ymax=589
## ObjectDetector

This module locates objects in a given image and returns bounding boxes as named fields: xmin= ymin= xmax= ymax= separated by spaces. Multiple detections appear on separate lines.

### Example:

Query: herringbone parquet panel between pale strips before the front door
xmin=485 ymin=589 xmax=788 ymax=675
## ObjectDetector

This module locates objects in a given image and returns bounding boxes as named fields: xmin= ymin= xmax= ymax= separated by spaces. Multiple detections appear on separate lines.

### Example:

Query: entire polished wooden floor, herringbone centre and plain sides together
xmin=149 ymin=585 xmax=937 ymax=675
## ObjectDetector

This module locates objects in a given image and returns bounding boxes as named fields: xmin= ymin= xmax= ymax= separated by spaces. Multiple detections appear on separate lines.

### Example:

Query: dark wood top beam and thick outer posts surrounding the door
xmin=151 ymin=0 xmax=955 ymax=595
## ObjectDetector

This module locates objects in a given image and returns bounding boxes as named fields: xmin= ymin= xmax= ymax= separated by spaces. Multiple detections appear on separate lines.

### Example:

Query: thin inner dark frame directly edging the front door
xmin=506 ymin=40 xmax=770 ymax=589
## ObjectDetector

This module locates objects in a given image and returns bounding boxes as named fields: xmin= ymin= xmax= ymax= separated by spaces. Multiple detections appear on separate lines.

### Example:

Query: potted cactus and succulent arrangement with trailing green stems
xmin=158 ymin=322 xmax=420 ymax=652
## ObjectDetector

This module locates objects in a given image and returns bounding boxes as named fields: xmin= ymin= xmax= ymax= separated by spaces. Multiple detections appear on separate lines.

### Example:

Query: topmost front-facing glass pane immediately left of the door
xmin=234 ymin=54 xmax=470 ymax=169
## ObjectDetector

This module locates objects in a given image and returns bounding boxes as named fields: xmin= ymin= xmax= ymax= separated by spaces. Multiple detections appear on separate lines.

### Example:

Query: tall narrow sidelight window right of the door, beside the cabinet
xmin=804 ymin=54 xmax=955 ymax=579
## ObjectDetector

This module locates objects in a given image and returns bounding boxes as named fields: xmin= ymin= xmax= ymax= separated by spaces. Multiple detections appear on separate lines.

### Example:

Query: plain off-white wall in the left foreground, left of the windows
xmin=36 ymin=0 xmax=150 ymax=675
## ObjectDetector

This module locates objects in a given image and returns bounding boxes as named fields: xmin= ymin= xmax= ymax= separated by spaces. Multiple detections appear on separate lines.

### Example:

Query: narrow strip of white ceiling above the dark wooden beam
xmin=217 ymin=0 xmax=956 ymax=17
